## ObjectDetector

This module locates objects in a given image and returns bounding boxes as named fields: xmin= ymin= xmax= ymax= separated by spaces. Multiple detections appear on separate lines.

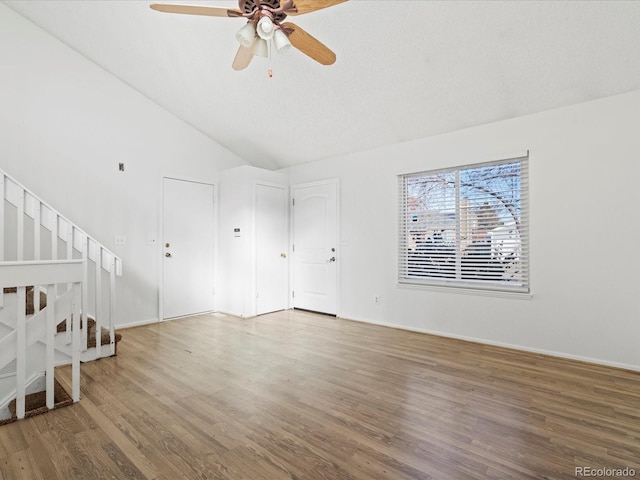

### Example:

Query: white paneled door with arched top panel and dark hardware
xmin=292 ymin=182 xmax=339 ymax=315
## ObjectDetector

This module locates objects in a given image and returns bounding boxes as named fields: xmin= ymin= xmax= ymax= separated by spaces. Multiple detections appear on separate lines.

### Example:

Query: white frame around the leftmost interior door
xmin=159 ymin=175 xmax=219 ymax=323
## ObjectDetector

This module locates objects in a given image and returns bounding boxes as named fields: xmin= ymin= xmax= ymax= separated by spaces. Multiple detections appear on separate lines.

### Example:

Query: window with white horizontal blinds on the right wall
xmin=398 ymin=154 xmax=529 ymax=292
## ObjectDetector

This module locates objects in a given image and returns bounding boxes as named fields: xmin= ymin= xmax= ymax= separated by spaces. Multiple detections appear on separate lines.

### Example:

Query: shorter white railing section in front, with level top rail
xmin=0 ymin=260 xmax=86 ymax=419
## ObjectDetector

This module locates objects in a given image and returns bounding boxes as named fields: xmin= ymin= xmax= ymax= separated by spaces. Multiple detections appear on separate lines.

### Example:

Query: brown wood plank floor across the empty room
xmin=0 ymin=311 xmax=640 ymax=480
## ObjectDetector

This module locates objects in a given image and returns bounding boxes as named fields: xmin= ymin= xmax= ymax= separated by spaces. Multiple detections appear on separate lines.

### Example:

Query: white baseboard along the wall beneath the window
xmin=338 ymin=317 xmax=640 ymax=372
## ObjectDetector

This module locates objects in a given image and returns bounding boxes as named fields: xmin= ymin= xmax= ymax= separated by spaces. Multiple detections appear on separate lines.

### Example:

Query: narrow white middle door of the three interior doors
xmin=255 ymin=184 xmax=288 ymax=315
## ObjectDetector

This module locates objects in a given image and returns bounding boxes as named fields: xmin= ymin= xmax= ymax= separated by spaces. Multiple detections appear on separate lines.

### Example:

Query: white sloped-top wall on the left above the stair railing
xmin=0 ymin=4 xmax=245 ymax=324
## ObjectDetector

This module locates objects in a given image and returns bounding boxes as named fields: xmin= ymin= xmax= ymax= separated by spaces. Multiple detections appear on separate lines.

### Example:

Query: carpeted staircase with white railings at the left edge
xmin=0 ymin=170 xmax=122 ymax=424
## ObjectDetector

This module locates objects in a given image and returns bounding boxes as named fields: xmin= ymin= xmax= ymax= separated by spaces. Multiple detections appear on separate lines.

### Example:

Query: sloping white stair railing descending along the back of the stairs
xmin=0 ymin=170 xmax=122 ymax=358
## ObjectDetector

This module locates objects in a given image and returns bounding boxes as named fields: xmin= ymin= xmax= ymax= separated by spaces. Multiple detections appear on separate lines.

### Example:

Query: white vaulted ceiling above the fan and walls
xmin=3 ymin=0 xmax=640 ymax=169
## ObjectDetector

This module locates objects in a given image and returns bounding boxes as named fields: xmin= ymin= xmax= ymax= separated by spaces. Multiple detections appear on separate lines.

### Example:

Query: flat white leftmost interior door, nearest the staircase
xmin=162 ymin=178 xmax=215 ymax=318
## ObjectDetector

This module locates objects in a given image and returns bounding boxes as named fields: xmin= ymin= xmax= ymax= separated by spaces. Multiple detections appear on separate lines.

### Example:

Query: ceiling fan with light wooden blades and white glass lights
xmin=150 ymin=0 xmax=347 ymax=71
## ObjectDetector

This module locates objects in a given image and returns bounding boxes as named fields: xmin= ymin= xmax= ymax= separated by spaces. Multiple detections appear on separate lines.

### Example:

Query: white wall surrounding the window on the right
xmin=285 ymin=91 xmax=640 ymax=369
